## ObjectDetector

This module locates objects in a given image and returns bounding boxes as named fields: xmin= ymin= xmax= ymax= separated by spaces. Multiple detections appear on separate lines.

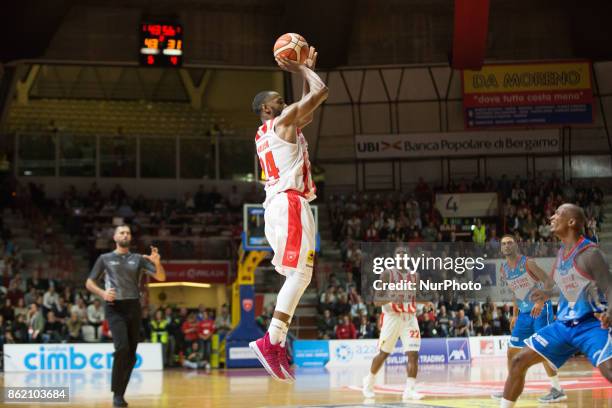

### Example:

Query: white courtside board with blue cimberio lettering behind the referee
xmin=4 ymin=343 xmax=163 ymax=372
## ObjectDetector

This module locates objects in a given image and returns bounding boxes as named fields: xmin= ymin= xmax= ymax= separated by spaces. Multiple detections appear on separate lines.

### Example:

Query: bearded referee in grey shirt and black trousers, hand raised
xmin=85 ymin=225 xmax=166 ymax=407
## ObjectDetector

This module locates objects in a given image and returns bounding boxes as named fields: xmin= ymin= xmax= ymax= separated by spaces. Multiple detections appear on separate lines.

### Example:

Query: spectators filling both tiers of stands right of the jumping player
xmin=317 ymin=176 xmax=604 ymax=339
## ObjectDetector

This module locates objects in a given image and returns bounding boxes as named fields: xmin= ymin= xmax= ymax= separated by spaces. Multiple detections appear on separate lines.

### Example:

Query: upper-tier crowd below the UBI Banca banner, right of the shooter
xmin=327 ymin=176 xmax=603 ymax=253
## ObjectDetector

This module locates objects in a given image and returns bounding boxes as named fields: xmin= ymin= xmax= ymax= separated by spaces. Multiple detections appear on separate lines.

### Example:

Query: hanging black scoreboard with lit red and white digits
xmin=140 ymin=22 xmax=183 ymax=67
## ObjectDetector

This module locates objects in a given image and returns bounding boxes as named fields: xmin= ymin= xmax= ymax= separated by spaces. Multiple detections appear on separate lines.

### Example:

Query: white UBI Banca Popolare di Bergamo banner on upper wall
xmin=355 ymin=129 xmax=561 ymax=160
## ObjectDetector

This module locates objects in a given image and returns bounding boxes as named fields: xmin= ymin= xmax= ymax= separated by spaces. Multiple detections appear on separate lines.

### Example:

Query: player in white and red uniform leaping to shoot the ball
xmin=249 ymin=47 xmax=328 ymax=382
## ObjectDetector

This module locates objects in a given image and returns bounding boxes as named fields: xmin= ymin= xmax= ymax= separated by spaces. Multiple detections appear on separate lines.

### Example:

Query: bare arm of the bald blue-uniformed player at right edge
xmin=576 ymin=247 xmax=612 ymax=329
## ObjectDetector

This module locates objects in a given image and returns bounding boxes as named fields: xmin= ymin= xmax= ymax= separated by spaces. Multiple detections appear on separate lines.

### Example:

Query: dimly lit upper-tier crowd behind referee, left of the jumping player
xmin=7 ymin=183 xmax=263 ymax=263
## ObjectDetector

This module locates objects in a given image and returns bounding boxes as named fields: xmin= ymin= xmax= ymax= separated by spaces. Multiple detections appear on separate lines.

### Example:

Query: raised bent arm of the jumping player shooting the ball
xmin=276 ymin=58 xmax=329 ymax=128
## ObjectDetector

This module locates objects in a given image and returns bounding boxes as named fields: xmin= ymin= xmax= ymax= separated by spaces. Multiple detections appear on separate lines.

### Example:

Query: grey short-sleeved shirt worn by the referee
xmin=89 ymin=251 xmax=155 ymax=300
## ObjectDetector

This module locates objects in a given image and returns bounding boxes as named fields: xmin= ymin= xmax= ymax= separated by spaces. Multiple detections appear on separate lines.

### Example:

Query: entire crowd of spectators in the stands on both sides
xmin=0 ymin=172 xmax=604 ymax=356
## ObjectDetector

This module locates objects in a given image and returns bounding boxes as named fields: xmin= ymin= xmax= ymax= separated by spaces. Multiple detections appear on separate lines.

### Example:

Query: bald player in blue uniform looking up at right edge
xmin=501 ymin=204 xmax=612 ymax=408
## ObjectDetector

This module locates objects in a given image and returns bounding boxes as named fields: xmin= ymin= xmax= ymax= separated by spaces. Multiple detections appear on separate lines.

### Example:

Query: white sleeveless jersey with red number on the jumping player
xmin=255 ymin=118 xmax=316 ymax=208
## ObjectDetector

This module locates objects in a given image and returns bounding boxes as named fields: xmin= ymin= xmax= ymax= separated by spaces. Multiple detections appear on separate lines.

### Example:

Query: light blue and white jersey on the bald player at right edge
xmin=553 ymin=237 xmax=607 ymax=321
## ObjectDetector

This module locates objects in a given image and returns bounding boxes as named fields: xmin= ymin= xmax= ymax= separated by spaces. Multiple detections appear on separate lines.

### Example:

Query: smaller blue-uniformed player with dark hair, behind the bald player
xmin=492 ymin=235 xmax=567 ymax=403
